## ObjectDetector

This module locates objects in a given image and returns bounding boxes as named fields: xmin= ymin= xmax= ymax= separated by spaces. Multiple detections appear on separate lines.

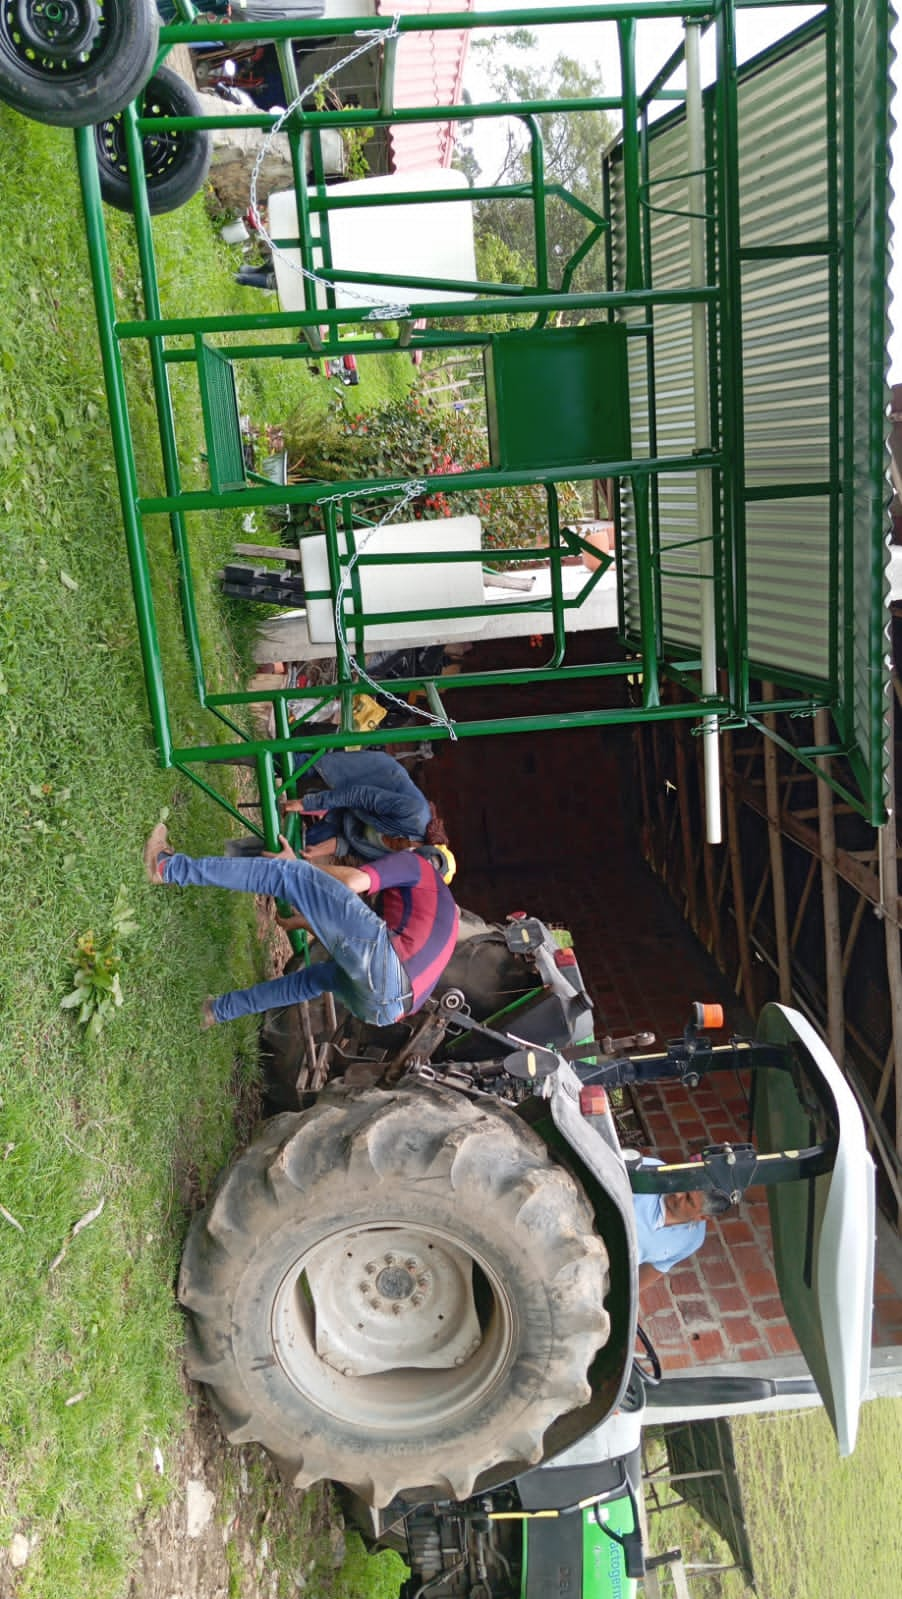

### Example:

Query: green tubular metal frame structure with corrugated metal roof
xmin=68 ymin=0 xmax=891 ymax=846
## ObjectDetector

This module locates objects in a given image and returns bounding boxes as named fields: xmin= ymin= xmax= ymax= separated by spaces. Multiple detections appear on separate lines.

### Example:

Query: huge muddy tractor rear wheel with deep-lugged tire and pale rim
xmin=179 ymin=1086 xmax=609 ymax=1506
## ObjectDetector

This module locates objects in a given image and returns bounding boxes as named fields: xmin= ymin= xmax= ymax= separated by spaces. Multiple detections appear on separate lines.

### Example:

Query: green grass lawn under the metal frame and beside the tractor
xmin=0 ymin=109 xmax=401 ymax=1599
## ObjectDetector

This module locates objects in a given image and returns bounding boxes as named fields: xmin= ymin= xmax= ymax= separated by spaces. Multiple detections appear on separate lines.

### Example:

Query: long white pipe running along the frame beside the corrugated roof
xmin=686 ymin=22 xmax=723 ymax=844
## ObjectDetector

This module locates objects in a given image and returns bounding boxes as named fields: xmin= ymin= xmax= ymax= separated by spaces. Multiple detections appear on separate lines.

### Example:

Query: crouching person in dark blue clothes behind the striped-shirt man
xmin=285 ymin=750 xmax=448 ymax=860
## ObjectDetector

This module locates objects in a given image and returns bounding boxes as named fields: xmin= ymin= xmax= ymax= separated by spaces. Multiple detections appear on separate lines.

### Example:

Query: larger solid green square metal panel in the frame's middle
xmin=485 ymin=321 xmax=630 ymax=472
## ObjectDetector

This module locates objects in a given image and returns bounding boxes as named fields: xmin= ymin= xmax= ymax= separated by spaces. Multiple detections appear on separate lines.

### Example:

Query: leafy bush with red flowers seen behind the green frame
xmin=278 ymin=393 xmax=582 ymax=550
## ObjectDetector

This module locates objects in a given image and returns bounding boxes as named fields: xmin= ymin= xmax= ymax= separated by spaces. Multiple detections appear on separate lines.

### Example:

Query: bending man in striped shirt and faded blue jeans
xmin=144 ymin=822 xmax=459 ymax=1027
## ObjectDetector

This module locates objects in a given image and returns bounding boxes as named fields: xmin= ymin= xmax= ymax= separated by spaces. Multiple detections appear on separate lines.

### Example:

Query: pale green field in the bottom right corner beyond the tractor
xmin=651 ymin=1399 xmax=902 ymax=1599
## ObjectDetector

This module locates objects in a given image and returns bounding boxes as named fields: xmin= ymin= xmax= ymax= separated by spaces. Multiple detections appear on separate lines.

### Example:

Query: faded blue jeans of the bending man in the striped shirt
xmin=163 ymin=854 xmax=411 ymax=1027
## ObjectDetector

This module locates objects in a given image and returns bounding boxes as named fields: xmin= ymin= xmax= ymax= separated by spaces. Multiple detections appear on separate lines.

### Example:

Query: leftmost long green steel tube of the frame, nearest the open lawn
xmin=75 ymin=128 xmax=173 ymax=766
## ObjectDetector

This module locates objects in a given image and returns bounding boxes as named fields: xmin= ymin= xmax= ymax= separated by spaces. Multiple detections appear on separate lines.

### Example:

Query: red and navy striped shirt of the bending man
xmin=360 ymin=849 xmax=461 ymax=1011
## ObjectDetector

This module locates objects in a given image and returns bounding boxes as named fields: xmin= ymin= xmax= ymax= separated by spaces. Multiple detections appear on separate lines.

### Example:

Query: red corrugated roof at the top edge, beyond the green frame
xmin=376 ymin=0 xmax=473 ymax=173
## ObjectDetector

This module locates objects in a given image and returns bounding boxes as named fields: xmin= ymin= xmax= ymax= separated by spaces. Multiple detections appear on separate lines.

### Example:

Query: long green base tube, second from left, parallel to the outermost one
xmin=122 ymin=106 xmax=206 ymax=705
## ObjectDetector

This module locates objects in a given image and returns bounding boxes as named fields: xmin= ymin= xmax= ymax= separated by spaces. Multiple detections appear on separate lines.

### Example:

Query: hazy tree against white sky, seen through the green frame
xmin=459 ymin=29 xmax=614 ymax=302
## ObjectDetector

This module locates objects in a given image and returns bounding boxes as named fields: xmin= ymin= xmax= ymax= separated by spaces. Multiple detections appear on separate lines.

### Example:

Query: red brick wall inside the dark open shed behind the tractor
xmin=422 ymin=643 xmax=902 ymax=1369
